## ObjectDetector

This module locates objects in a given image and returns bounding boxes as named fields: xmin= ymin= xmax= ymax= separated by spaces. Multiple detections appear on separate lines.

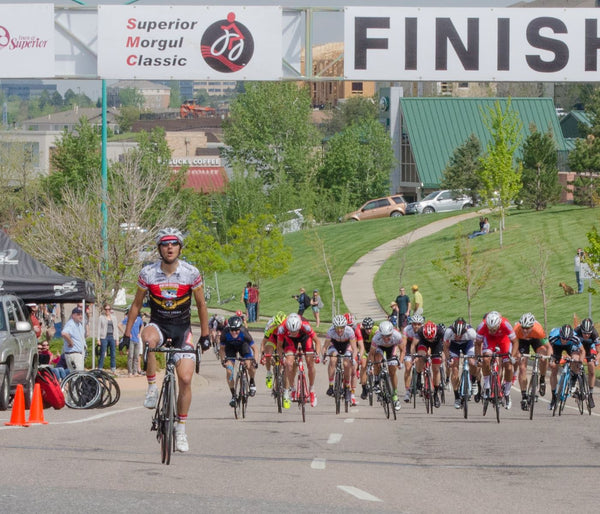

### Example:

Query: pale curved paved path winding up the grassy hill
xmin=341 ymin=212 xmax=481 ymax=319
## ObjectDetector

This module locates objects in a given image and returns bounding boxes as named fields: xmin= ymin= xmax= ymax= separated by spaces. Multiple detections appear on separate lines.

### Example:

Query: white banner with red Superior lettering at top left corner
xmin=0 ymin=4 xmax=54 ymax=78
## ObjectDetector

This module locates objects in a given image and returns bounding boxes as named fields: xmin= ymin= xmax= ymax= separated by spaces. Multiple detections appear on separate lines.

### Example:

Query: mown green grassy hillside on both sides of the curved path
xmin=206 ymin=205 xmax=600 ymax=326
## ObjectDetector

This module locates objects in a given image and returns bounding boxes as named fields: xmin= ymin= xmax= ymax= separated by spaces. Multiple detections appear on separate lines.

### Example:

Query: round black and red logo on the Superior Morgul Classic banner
xmin=200 ymin=12 xmax=254 ymax=73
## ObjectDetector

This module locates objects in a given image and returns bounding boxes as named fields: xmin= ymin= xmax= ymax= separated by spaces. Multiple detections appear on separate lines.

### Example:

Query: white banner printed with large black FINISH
xmin=344 ymin=7 xmax=600 ymax=82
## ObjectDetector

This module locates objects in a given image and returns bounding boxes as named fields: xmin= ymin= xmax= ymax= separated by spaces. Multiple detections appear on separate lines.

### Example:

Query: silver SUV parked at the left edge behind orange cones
xmin=0 ymin=294 xmax=38 ymax=410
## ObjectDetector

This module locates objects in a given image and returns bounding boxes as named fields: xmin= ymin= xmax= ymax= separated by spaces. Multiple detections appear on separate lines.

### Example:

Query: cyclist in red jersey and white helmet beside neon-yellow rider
xmin=277 ymin=313 xmax=321 ymax=409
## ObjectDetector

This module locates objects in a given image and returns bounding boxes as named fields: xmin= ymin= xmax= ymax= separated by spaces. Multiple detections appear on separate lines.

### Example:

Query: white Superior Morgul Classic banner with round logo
xmin=98 ymin=5 xmax=282 ymax=80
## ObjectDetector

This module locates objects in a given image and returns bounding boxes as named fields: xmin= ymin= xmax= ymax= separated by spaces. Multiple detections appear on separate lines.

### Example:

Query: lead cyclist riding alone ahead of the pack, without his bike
xmin=123 ymin=228 xmax=210 ymax=452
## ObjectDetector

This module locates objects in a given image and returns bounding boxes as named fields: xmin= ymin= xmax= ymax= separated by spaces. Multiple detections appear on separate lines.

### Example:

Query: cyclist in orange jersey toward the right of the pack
xmin=514 ymin=312 xmax=552 ymax=410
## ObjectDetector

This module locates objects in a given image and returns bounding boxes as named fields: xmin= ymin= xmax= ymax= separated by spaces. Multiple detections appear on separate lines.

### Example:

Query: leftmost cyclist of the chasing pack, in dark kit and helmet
xmin=219 ymin=316 xmax=256 ymax=407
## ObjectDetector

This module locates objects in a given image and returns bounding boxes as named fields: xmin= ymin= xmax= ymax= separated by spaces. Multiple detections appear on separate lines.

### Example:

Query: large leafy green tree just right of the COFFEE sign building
xmin=223 ymin=82 xmax=319 ymax=186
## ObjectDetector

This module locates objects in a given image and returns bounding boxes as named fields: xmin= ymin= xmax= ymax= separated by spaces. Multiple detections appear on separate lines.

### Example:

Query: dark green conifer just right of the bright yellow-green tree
xmin=519 ymin=126 xmax=561 ymax=211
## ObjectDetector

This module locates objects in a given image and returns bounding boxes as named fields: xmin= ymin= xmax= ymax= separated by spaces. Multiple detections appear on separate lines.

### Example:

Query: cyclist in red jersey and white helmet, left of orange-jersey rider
xmin=475 ymin=311 xmax=519 ymax=409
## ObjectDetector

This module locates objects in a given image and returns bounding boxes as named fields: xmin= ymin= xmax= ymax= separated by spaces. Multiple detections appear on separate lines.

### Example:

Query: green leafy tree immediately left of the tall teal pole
xmin=45 ymin=117 xmax=102 ymax=201
